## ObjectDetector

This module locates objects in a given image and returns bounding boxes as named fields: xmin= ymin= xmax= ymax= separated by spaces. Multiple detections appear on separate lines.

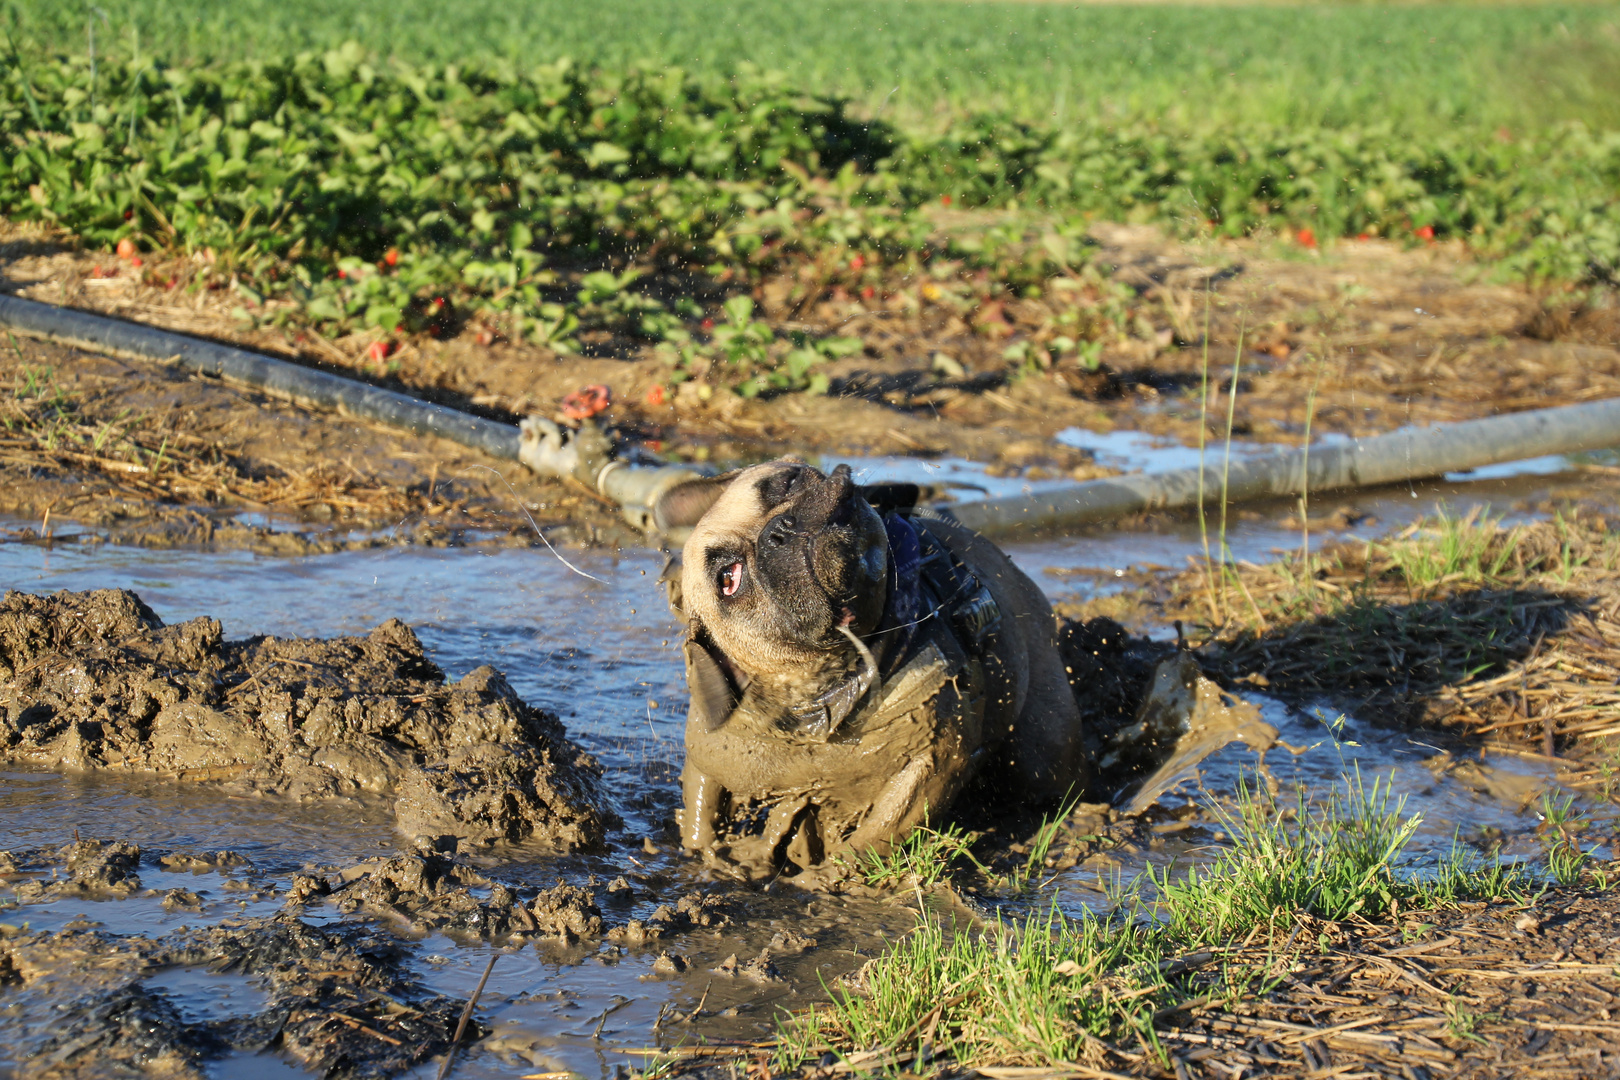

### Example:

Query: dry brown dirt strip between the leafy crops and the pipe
xmin=0 ymin=214 xmax=1620 ymax=508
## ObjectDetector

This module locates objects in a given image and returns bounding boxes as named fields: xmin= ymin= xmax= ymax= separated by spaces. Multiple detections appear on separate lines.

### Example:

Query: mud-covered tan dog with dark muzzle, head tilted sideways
xmin=659 ymin=460 xmax=1087 ymax=884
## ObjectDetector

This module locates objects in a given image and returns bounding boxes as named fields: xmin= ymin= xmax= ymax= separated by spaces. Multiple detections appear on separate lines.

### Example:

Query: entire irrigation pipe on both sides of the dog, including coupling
xmin=0 ymin=293 xmax=1620 ymax=539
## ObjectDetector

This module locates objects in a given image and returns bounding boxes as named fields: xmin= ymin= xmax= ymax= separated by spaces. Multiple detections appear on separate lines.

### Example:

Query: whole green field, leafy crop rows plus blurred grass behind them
xmin=0 ymin=0 xmax=1620 ymax=392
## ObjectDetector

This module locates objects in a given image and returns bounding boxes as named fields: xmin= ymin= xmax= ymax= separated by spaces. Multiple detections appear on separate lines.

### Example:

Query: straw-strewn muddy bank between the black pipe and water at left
xmin=0 ymin=331 xmax=638 ymax=555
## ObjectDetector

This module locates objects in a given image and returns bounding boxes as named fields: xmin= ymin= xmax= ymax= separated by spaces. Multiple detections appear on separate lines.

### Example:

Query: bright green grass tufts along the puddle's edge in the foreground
xmin=790 ymin=774 xmax=1528 ymax=1072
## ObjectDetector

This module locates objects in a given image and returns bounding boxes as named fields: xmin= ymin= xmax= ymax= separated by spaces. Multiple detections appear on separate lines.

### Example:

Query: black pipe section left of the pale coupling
xmin=0 ymin=295 xmax=518 ymax=460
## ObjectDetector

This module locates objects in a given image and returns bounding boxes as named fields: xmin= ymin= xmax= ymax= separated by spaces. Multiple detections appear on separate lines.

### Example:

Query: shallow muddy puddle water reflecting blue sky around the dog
xmin=0 ymin=442 xmax=1607 ymax=1077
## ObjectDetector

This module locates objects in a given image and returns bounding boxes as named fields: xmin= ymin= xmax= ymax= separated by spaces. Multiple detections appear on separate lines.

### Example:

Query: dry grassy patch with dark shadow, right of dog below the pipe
xmin=1166 ymin=513 xmax=1620 ymax=755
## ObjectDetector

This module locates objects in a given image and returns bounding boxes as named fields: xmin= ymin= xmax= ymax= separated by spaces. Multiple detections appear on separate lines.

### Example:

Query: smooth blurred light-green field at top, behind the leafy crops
xmin=15 ymin=0 xmax=1620 ymax=128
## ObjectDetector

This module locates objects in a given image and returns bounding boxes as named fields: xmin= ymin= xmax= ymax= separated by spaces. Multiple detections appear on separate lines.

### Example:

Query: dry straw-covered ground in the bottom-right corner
xmin=1146 ymin=889 xmax=1620 ymax=1080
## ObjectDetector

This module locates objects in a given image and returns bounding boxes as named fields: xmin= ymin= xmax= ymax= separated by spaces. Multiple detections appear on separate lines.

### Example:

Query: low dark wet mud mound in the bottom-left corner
xmin=0 ymin=916 xmax=478 ymax=1080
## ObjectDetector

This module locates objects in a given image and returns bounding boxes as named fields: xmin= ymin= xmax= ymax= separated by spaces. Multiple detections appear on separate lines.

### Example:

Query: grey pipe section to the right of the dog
xmin=948 ymin=398 xmax=1620 ymax=536
